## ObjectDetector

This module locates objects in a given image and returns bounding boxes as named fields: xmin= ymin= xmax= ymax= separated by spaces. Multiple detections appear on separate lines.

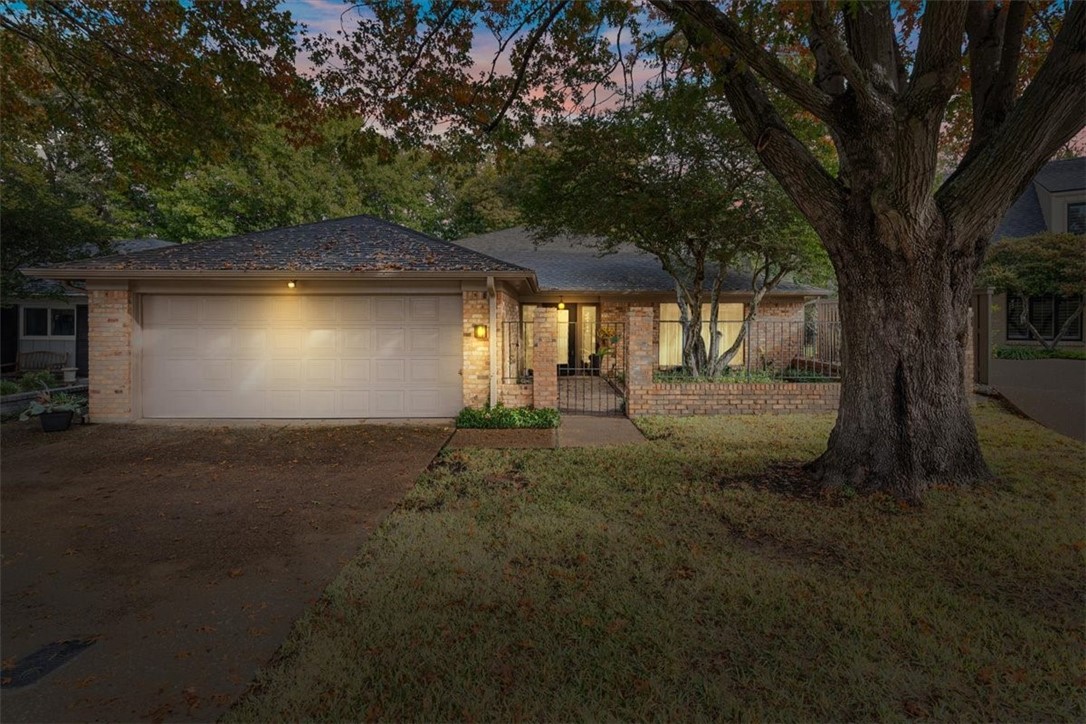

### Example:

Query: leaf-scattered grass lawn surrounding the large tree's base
xmin=228 ymin=405 xmax=1086 ymax=721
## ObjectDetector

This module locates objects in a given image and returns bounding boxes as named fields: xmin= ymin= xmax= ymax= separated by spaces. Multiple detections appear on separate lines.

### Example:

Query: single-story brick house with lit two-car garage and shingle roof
xmin=27 ymin=216 xmax=821 ymax=421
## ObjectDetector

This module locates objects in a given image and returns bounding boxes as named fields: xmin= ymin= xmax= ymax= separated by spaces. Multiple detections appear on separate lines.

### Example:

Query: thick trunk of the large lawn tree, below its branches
xmin=808 ymin=223 xmax=990 ymax=500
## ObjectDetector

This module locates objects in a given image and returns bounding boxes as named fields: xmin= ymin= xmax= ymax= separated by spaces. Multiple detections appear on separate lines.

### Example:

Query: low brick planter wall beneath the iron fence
xmin=627 ymin=382 xmax=841 ymax=417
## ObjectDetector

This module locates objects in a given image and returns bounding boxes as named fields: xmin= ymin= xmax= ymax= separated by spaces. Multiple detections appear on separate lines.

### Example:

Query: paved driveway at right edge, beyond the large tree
xmin=989 ymin=359 xmax=1086 ymax=442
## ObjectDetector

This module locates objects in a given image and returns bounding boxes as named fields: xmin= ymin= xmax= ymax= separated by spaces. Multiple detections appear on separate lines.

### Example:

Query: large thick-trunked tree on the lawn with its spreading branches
xmin=316 ymin=0 xmax=1086 ymax=498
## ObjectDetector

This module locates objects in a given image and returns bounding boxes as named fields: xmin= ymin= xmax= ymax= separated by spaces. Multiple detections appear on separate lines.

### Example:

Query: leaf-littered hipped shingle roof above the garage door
xmin=42 ymin=216 xmax=530 ymax=275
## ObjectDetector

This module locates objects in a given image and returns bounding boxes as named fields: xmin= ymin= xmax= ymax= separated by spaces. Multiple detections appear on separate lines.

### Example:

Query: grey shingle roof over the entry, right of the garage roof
xmin=456 ymin=227 xmax=826 ymax=295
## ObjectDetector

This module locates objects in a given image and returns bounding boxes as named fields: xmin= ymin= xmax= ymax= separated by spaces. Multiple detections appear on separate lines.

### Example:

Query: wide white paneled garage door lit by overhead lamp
xmin=141 ymin=294 xmax=463 ymax=418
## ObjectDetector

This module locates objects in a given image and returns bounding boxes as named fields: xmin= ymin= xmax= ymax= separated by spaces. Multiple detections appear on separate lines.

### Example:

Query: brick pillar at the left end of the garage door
xmin=87 ymin=290 xmax=135 ymax=422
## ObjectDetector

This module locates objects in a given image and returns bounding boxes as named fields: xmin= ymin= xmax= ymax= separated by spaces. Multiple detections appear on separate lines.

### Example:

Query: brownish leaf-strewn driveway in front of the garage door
xmin=0 ymin=422 xmax=452 ymax=722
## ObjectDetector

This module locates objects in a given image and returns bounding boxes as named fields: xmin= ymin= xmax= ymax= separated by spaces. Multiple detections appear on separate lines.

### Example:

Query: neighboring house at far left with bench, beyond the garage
xmin=0 ymin=239 xmax=175 ymax=378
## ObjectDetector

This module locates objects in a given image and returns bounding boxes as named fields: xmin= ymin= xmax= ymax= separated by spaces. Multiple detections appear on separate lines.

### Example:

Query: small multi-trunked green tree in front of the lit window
xmin=519 ymin=82 xmax=828 ymax=377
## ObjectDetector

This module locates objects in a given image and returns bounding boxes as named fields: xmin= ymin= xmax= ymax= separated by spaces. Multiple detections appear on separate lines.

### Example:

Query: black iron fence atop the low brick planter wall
xmin=656 ymin=319 xmax=842 ymax=382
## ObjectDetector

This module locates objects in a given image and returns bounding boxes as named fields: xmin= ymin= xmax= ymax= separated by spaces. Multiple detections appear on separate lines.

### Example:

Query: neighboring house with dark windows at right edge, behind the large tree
xmin=974 ymin=157 xmax=1086 ymax=384
